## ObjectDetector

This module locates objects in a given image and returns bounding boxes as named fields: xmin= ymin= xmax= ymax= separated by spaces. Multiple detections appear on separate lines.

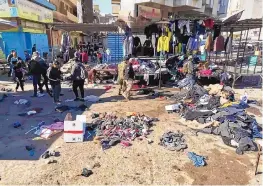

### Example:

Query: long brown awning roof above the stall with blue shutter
xmin=52 ymin=23 xmax=118 ymax=33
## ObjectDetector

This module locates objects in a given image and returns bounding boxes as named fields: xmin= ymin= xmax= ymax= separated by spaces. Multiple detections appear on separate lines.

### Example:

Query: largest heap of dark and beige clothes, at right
xmin=171 ymin=84 xmax=262 ymax=154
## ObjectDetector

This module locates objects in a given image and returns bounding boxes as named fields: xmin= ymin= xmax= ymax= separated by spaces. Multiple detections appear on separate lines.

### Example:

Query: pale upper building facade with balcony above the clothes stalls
xmin=115 ymin=0 xmax=228 ymax=19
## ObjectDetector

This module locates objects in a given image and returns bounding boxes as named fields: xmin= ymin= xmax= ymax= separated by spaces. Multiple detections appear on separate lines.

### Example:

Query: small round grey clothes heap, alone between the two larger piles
xmin=159 ymin=131 xmax=187 ymax=151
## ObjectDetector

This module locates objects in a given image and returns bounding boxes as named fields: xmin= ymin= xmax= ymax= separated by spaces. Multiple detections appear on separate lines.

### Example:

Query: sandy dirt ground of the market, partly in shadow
xmin=0 ymin=75 xmax=262 ymax=185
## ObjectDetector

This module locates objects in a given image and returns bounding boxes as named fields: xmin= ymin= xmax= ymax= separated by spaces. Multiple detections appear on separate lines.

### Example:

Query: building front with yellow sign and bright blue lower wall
xmin=0 ymin=0 xmax=56 ymax=58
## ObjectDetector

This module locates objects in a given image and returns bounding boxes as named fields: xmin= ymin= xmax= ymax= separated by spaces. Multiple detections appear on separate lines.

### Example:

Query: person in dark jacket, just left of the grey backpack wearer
xmin=47 ymin=61 xmax=62 ymax=104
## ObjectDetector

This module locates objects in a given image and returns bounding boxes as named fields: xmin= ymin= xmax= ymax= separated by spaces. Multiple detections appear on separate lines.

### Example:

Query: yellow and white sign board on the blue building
xmin=0 ymin=0 xmax=53 ymax=23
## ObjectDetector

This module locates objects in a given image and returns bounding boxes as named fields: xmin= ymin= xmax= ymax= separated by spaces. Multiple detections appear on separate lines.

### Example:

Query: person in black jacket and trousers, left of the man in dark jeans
xmin=29 ymin=52 xmax=43 ymax=97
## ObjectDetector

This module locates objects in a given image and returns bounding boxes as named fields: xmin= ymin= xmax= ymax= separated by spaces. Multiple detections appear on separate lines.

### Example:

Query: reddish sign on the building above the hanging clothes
xmin=138 ymin=5 xmax=161 ymax=19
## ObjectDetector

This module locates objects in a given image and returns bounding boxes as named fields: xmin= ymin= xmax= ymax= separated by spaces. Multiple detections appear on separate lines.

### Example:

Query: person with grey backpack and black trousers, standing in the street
xmin=71 ymin=59 xmax=87 ymax=101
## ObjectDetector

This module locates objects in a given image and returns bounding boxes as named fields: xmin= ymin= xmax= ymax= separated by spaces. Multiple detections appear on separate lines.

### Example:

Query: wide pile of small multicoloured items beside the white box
xmin=91 ymin=113 xmax=158 ymax=149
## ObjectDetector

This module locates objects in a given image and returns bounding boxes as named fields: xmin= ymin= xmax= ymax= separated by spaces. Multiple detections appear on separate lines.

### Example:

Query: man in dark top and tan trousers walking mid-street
xmin=122 ymin=58 xmax=135 ymax=100
